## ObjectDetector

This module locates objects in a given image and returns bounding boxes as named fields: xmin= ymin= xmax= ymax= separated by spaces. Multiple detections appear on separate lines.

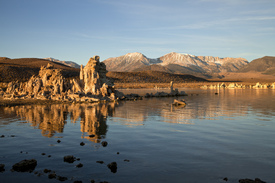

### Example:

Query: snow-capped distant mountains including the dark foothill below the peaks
xmin=103 ymin=52 xmax=248 ymax=76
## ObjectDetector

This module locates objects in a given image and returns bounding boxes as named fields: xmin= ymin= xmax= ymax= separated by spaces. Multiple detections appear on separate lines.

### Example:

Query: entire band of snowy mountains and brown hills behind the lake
xmin=0 ymin=52 xmax=275 ymax=82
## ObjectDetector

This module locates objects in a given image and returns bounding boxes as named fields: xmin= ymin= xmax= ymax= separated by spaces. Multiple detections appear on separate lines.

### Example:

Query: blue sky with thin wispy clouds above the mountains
xmin=0 ymin=0 xmax=275 ymax=65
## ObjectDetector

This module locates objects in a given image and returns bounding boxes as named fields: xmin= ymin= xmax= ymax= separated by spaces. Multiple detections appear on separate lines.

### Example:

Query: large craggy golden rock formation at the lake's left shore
xmin=1 ymin=56 xmax=129 ymax=102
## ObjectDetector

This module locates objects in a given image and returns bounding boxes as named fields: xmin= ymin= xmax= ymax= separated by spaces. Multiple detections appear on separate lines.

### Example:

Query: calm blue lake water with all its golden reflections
xmin=0 ymin=89 xmax=275 ymax=183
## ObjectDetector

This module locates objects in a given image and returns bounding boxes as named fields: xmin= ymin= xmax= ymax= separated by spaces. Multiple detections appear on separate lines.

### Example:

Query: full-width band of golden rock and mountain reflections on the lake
xmin=0 ymin=89 xmax=275 ymax=137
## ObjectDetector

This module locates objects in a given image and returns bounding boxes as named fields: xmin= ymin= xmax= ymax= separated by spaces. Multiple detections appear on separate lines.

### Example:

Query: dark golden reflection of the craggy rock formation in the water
xmin=3 ymin=103 xmax=117 ymax=142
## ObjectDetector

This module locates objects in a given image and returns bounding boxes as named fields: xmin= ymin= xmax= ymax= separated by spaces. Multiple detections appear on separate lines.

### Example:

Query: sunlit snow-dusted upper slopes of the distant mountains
xmin=103 ymin=52 xmax=247 ymax=72
